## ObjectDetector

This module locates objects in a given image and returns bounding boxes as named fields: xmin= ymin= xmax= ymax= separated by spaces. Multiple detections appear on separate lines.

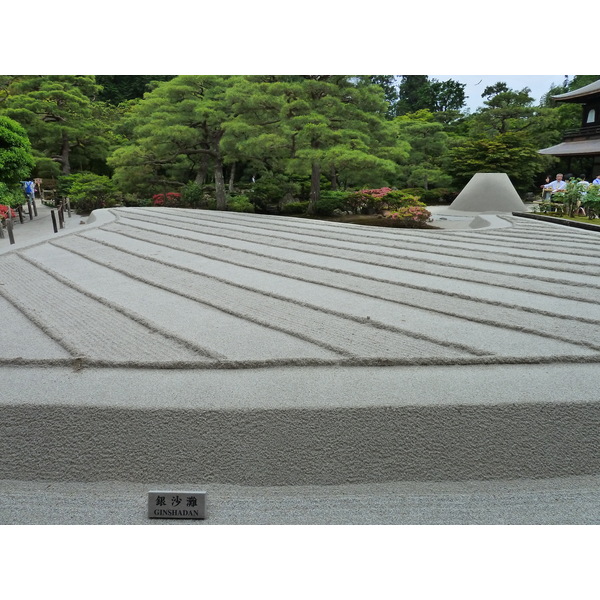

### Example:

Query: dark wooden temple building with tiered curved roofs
xmin=539 ymin=79 xmax=600 ymax=177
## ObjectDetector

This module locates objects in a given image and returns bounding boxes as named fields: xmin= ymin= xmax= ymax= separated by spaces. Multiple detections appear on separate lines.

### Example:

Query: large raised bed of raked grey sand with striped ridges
xmin=0 ymin=208 xmax=600 ymax=524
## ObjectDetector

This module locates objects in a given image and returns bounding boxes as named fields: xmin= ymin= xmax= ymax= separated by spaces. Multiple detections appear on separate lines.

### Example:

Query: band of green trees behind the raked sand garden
xmin=0 ymin=75 xmax=600 ymax=212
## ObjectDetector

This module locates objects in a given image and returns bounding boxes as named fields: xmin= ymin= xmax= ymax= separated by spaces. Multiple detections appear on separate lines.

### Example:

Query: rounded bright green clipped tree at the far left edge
xmin=0 ymin=116 xmax=35 ymax=183
